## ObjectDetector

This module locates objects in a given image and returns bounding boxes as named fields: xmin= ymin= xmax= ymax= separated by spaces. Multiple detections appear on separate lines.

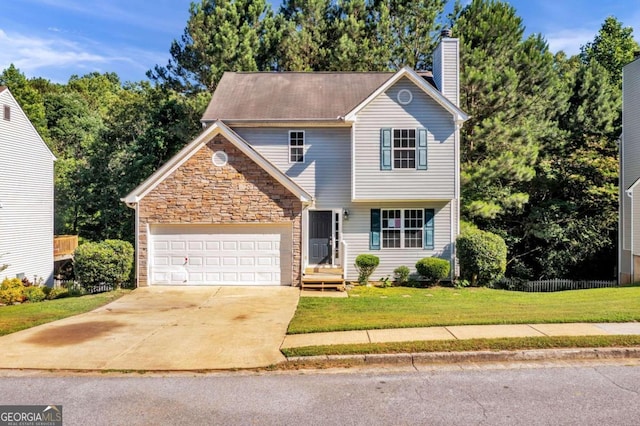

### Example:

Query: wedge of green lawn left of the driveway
xmin=0 ymin=290 xmax=131 ymax=336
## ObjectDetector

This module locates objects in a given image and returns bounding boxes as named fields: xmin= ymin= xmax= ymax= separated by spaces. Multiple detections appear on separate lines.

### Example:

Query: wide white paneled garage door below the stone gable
xmin=149 ymin=224 xmax=292 ymax=285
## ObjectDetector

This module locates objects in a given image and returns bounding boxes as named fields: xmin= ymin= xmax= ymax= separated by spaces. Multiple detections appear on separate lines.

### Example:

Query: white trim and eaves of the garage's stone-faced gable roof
xmin=121 ymin=121 xmax=313 ymax=204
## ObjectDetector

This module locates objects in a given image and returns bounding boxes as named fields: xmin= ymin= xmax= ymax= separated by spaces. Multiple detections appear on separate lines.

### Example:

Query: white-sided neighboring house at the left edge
xmin=0 ymin=86 xmax=55 ymax=285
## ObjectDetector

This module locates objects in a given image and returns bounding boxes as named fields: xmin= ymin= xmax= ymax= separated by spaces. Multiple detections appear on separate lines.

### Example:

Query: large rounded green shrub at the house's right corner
xmin=456 ymin=229 xmax=507 ymax=286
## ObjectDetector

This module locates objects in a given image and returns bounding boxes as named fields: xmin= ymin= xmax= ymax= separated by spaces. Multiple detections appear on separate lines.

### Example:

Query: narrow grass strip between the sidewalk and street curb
xmin=282 ymin=335 xmax=640 ymax=357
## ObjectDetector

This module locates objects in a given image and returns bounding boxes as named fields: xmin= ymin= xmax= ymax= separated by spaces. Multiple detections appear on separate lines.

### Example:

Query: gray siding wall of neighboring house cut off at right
xmin=619 ymin=60 xmax=640 ymax=274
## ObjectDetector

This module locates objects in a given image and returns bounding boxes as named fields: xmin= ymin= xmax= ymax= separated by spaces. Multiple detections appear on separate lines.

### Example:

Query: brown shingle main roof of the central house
xmin=202 ymin=72 xmax=430 ymax=121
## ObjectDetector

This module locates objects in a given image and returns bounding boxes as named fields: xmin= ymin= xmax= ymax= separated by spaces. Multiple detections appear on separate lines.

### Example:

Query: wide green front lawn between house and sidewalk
xmin=289 ymin=287 xmax=640 ymax=334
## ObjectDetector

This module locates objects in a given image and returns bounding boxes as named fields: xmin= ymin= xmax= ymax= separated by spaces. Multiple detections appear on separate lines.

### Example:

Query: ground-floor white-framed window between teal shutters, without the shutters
xmin=381 ymin=209 xmax=424 ymax=248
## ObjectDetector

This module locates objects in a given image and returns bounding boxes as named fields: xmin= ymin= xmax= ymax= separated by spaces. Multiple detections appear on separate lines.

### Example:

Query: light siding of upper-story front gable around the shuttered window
xmin=353 ymin=78 xmax=456 ymax=201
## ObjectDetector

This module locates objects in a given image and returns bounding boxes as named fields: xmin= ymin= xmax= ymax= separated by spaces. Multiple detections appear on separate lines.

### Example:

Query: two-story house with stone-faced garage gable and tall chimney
xmin=123 ymin=33 xmax=468 ymax=286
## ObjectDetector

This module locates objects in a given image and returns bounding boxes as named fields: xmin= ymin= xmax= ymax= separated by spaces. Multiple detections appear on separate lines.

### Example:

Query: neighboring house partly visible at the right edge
xmin=618 ymin=58 xmax=640 ymax=284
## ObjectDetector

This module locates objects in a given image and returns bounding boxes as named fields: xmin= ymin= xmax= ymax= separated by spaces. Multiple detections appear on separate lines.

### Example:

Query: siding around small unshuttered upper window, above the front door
xmin=234 ymin=127 xmax=351 ymax=209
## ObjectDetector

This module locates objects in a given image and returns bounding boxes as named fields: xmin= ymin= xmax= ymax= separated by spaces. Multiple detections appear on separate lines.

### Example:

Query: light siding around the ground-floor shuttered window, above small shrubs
xmin=342 ymin=201 xmax=457 ymax=281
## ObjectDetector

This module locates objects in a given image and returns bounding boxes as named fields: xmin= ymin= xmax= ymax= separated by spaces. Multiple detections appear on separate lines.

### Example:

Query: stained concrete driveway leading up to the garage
xmin=0 ymin=287 xmax=300 ymax=370
